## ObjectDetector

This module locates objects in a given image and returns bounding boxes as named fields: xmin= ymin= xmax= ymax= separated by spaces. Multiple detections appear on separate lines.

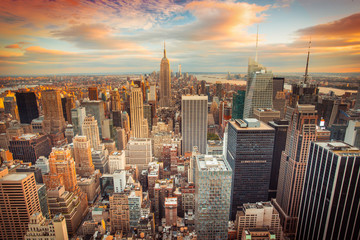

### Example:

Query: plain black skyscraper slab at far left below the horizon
xmin=15 ymin=91 xmax=39 ymax=124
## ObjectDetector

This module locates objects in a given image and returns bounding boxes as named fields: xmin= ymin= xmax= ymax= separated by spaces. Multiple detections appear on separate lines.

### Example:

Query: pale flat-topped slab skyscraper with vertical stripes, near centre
xmin=181 ymin=96 xmax=208 ymax=154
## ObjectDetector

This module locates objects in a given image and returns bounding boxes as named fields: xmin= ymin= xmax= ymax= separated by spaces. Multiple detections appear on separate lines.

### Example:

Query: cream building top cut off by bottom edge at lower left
xmin=24 ymin=212 xmax=69 ymax=240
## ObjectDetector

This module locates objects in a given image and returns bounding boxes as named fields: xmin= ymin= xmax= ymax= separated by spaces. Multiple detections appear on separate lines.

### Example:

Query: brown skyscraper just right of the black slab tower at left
xmin=41 ymin=90 xmax=66 ymax=134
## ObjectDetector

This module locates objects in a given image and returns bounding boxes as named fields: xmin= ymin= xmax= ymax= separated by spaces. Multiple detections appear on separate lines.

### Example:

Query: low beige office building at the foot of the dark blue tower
xmin=236 ymin=202 xmax=283 ymax=240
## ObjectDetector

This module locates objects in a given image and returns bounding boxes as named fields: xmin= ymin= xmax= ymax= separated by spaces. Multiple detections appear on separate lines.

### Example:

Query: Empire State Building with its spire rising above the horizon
xmin=160 ymin=43 xmax=171 ymax=107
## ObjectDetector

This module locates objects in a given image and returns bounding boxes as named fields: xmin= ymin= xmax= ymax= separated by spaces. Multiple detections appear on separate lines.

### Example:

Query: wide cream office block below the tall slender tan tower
xmin=125 ymin=138 xmax=152 ymax=172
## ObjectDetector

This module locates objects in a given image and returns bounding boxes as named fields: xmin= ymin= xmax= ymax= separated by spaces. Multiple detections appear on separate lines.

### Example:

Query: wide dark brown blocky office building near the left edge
xmin=9 ymin=133 xmax=51 ymax=164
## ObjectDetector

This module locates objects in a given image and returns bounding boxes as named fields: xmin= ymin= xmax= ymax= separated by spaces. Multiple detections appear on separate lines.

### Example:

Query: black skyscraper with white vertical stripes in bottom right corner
xmin=296 ymin=141 xmax=360 ymax=240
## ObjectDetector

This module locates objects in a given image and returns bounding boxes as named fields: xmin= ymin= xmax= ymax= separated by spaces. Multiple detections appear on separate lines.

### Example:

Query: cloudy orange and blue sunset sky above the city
xmin=0 ymin=0 xmax=360 ymax=75
